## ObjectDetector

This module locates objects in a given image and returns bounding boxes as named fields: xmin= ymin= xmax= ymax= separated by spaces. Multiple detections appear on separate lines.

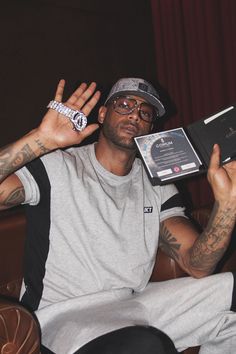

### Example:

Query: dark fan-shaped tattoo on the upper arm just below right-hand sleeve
xmin=159 ymin=222 xmax=181 ymax=260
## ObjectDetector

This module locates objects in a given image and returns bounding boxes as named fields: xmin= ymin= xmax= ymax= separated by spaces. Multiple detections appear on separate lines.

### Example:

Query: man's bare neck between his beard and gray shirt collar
xmin=95 ymin=139 xmax=136 ymax=176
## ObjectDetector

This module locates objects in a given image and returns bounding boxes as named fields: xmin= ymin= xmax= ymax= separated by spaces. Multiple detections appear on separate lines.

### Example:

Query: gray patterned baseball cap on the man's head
xmin=105 ymin=78 xmax=165 ymax=117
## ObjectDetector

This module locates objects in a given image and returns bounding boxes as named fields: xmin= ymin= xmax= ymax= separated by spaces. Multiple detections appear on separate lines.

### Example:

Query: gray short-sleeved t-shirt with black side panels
xmin=16 ymin=144 xmax=184 ymax=310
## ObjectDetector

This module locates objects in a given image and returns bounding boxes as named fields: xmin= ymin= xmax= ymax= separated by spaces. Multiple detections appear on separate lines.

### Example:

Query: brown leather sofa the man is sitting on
xmin=0 ymin=208 xmax=236 ymax=354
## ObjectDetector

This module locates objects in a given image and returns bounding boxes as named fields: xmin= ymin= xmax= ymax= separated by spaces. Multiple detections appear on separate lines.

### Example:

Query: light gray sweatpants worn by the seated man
xmin=38 ymin=273 xmax=236 ymax=354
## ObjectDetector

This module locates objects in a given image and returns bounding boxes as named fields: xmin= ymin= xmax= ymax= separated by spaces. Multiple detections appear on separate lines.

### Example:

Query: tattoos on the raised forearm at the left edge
xmin=0 ymin=144 xmax=36 ymax=181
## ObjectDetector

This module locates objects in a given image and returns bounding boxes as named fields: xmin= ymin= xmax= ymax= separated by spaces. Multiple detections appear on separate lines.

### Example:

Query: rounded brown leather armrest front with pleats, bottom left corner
xmin=0 ymin=298 xmax=40 ymax=354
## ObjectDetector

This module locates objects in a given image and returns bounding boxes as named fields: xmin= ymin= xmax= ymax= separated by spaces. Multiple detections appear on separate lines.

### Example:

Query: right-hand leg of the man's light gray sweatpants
xmin=136 ymin=273 xmax=236 ymax=354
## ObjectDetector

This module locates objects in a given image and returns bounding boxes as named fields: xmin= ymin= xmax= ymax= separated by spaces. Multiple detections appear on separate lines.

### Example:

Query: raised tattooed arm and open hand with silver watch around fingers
xmin=0 ymin=80 xmax=100 ymax=210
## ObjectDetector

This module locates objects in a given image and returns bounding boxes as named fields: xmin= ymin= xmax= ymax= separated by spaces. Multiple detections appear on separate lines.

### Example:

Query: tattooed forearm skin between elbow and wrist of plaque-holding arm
xmin=190 ymin=204 xmax=235 ymax=273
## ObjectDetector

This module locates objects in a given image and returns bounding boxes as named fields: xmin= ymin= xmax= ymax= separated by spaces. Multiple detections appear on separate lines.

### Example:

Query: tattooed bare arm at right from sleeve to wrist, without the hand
xmin=159 ymin=207 xmax=234 ymax=278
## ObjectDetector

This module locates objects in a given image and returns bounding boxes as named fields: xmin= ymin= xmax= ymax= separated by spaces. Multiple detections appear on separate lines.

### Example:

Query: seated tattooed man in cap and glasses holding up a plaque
xmin=0 ymin=78 xmax=236 ymax=354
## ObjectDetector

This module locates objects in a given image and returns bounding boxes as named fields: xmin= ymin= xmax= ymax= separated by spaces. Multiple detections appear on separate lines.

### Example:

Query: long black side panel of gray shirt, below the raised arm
xmin=21 ymin=158 xmax=51 ymax=311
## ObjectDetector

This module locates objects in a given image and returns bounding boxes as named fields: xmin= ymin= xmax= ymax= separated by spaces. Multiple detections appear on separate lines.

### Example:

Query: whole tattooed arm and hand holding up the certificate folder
xmin=160 ymin=145 xmax=236 ymax=277
